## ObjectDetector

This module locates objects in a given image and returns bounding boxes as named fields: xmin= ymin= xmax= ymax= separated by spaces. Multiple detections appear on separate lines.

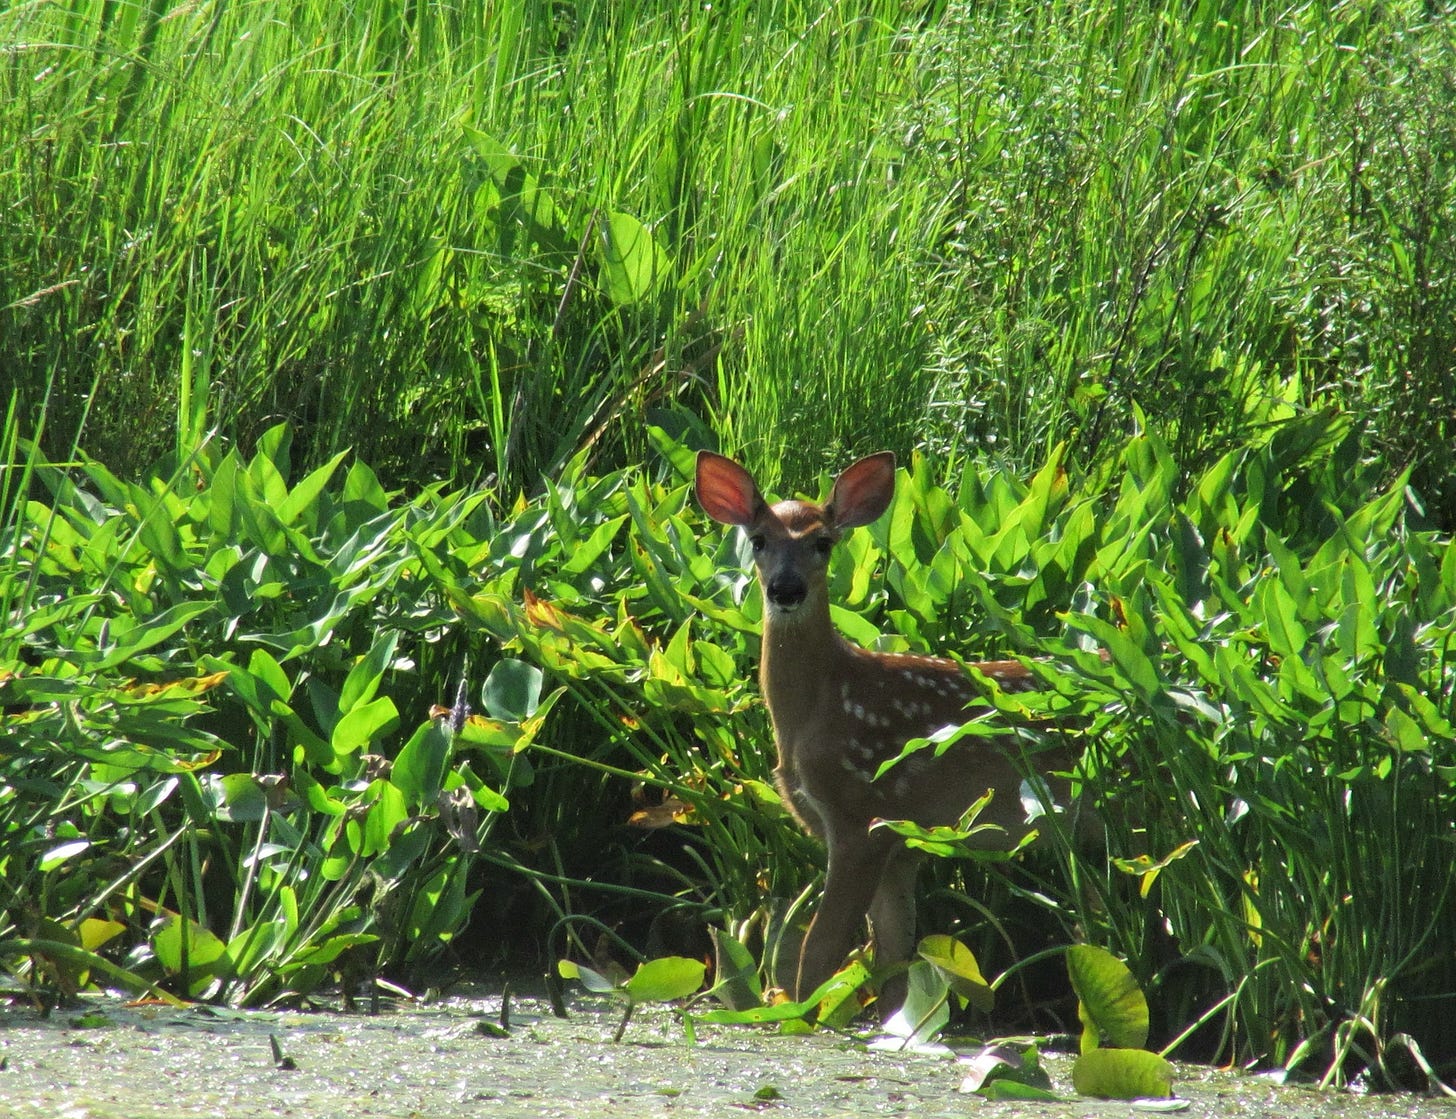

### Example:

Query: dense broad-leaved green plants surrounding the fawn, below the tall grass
xmin=0 ymin=415 xmax=1456 ymax=1082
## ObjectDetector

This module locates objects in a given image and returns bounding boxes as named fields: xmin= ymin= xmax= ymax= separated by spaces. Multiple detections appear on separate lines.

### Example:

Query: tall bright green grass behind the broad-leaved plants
xmin=0 ymin=0 xmax=1456 ymax=517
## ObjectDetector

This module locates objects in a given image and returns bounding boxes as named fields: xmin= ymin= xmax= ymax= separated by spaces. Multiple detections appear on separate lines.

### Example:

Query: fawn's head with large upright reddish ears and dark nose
xmin=697 ymin=451 xmax=895 ymax=618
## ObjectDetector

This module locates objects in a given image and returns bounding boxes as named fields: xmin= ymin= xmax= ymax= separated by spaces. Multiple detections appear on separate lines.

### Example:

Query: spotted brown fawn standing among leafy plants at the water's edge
xmin=697 ymin=451 xmax=1067 ymax=1005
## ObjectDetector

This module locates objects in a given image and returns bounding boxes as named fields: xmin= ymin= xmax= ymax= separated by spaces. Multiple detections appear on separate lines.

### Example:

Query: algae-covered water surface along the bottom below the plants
xmin=0 ymin=992 xmax=1456 ymax=1119
